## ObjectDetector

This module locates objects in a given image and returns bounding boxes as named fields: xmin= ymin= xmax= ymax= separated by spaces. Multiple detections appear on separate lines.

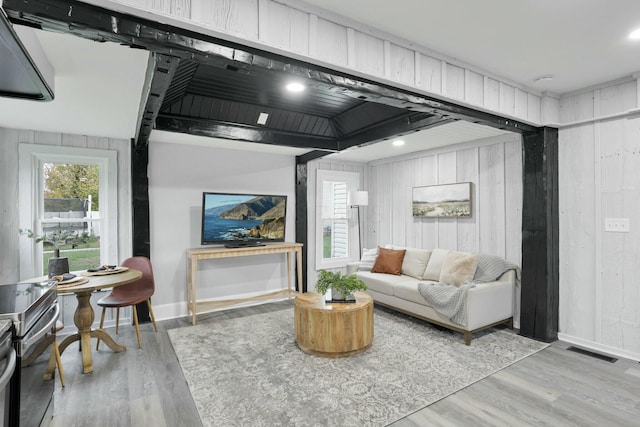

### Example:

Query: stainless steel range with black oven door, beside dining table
xmin=0 ymin=280 xmax=60 ymax=427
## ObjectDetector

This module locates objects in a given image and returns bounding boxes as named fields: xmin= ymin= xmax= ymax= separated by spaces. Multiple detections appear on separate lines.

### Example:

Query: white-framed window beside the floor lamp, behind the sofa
xmin=316 ymin=170 xmax=360 ymax=269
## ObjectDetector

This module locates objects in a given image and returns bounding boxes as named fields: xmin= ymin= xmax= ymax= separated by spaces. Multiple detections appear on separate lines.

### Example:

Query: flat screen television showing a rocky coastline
xmin=201 ymin=192 xmax=287 ymax=247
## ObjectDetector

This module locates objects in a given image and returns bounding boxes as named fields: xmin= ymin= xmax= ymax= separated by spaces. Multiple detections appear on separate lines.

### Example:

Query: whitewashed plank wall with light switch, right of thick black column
xmin=559 ymin=79 xmax=640 ymax=360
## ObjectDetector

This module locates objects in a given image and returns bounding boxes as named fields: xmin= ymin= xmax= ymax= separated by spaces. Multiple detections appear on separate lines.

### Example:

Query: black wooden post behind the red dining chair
xmin=131 ymin=139 xmax=151 ymax=322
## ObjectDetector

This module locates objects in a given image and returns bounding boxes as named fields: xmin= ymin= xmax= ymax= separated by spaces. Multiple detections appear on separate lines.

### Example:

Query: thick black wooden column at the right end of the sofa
xmin=520 ymin=127 xmax=559 ymax=342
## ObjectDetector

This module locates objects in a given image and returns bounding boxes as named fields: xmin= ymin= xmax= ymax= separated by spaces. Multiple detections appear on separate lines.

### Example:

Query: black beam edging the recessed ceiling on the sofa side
xmin=338 ymin=115 xmax=456 ymax=151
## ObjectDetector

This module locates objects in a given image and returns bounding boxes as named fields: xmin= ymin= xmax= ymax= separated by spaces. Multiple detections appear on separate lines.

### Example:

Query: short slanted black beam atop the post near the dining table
xmin=135 ymin=54 xmax=180 ymax=145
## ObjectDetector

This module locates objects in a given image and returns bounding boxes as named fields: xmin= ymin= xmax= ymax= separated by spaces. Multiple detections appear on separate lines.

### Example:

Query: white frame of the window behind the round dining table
xmin=18 ymin=143 xmax=118 ymax=280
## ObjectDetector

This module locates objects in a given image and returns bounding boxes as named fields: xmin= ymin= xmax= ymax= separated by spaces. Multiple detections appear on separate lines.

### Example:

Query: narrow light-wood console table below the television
xmin=187 ymin=243 xmax=302 ymax=325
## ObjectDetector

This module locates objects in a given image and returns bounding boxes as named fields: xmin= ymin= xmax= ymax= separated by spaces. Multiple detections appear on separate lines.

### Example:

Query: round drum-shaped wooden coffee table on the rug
xmin=294 ymin=292 xmax=373 ymax=358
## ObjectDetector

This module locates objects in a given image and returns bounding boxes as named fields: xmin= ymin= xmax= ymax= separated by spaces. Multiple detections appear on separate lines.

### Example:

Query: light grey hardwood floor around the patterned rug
xmin=52 ymin=301 xmax=640 ymax=427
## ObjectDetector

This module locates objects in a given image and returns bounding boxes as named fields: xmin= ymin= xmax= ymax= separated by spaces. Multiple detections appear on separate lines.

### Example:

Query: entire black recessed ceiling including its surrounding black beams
xmin=3 ymin=0 xmax=536 ymax=157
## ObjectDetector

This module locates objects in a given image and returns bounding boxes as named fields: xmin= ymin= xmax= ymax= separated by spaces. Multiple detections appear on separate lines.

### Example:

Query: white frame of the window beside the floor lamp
xmin=315 ymin=169 xmax=360 ymax=270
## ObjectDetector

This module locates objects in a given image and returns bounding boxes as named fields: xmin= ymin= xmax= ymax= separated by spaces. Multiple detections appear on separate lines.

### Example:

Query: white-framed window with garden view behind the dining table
xmin=19 ymin=144 xmax=118 ymax=277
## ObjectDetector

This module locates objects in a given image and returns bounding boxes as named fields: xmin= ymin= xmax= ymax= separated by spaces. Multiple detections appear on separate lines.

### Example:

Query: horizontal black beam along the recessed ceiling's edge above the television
xmin=156 ymin=114 xmax=338 ymax=152
